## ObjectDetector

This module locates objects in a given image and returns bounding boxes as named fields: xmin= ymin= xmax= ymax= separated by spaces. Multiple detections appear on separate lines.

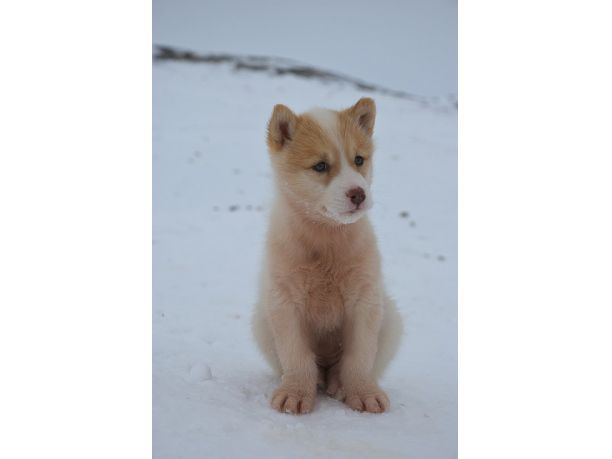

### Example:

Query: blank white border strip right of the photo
xmin=459 ymin=1 xmax=612 ymax=459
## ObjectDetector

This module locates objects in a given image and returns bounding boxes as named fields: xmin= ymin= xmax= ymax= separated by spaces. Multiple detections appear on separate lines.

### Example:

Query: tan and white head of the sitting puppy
xmin=268 ymin=98 xmax=376 ymax=224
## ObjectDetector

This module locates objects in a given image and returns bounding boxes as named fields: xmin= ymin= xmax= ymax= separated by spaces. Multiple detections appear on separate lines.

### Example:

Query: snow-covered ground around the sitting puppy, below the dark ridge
xmin=153 ymin=57 xmax=457 ymax=459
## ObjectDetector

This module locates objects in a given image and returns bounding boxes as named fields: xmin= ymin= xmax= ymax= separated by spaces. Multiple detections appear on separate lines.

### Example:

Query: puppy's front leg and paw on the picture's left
xmin=269 ymin=303 xmax=318 ymax=414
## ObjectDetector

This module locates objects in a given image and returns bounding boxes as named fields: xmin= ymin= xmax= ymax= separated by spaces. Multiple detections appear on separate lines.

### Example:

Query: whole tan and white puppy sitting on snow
xmin=253 ymin=98 xmax=402 ymax=414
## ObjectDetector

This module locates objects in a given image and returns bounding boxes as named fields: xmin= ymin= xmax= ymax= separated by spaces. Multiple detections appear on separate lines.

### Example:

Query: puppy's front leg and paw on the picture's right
xmin=340 ymin=295 xmax=389 ymax=413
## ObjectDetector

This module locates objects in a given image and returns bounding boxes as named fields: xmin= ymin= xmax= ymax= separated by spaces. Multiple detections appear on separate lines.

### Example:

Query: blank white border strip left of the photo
xmin=0 ymin=0 xmax=151 ymax=459
